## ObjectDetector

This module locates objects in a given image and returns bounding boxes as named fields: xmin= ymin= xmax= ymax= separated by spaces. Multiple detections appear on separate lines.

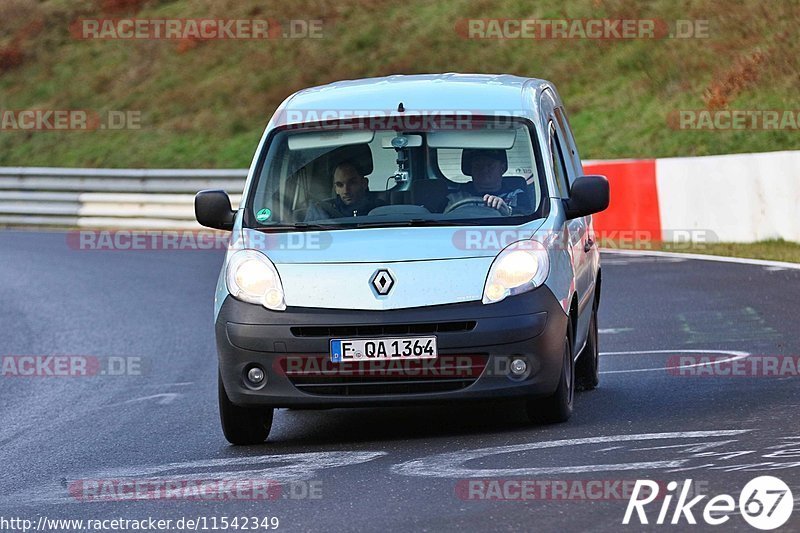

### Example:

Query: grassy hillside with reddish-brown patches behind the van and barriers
xmin=0 ymin=0 xmax=800 ymax=167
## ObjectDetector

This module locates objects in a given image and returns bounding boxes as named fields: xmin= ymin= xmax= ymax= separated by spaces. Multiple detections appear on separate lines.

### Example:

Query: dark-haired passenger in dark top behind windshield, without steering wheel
xmin=305 ymin=161 xmax=386 ymax=222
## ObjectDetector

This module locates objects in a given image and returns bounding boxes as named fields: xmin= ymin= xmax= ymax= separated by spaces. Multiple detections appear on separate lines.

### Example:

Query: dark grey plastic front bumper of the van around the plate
xmin=216 ymin=286 xmax=567 ymax=407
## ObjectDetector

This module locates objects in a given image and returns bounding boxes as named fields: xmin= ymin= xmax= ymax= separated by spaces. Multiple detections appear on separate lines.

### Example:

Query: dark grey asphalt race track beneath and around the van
xmin=0 ymin=231 xmax=800 ymax=531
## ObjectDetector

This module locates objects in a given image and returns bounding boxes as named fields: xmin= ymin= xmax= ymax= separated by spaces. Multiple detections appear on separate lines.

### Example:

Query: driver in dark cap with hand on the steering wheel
xmin=445 ymin=148 xmax=530 ymax=216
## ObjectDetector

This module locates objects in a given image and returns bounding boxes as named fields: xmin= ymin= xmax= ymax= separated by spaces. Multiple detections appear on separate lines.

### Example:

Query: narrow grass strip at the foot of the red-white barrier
xmin=601 ymin=239 xmax=800 ymax=263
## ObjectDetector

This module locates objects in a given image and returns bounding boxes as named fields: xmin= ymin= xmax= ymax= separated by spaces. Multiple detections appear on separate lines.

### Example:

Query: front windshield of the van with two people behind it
xmin=244 ymin=119 xmax=547 ymax=230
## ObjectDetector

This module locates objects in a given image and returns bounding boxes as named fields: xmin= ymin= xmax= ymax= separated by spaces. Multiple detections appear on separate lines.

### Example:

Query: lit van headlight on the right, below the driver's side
xmin=482 ymin=240 xmax=550 ymax=304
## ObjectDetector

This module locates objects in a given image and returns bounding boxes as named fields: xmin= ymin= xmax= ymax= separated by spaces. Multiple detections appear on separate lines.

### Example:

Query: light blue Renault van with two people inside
xmin=195 ymin=74 xmax=609 ymax=444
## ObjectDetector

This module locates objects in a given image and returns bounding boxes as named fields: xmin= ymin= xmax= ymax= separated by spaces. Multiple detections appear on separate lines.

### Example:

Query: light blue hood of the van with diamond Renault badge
xmin=236 ymin=220 xmax=544 ymax=310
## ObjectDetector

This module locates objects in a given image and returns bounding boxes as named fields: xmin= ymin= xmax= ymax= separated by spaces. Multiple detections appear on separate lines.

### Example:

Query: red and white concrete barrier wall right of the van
xmin=584 ymin=151 xmax=800 ymax=242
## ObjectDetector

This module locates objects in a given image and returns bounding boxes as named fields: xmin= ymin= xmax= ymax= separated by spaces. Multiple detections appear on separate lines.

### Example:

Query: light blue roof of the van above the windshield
xmin=276 ymin=73 xmax=557 ymax=123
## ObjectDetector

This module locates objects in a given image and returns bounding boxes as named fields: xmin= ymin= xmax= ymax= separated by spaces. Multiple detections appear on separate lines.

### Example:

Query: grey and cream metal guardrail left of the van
xmin=0 ymin=167 xmax=247 ymax=229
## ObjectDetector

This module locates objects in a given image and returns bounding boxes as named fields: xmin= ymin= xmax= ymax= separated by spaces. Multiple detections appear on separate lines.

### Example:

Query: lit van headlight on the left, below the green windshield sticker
xmin=225 ymin=250 xmax=286 ymax=311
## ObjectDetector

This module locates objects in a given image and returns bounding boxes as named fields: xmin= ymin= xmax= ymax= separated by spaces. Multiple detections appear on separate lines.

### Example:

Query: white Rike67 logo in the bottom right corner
xmin=622 ymin=476 xmax=794 ymax=530
